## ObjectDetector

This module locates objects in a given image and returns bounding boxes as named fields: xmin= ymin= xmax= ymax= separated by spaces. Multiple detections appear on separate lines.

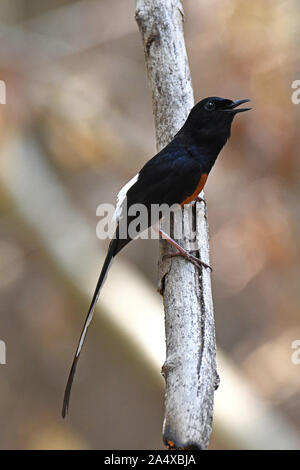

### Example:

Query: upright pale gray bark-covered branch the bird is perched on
xmin=136 ymin=0 xmax=218 ymax=449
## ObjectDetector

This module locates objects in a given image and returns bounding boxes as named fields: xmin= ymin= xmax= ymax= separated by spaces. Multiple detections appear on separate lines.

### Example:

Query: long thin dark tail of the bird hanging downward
xmin=62 ymin=231 xmax=131 ymax=418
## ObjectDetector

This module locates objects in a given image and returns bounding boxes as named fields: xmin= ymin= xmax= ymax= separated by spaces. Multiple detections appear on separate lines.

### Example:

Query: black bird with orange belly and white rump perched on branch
xmin=62 ymin=96 xmax=251 ymax=418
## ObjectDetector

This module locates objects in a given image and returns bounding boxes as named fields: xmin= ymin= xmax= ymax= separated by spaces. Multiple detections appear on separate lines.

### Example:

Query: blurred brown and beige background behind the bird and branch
xmin=0 ymin=0 xmax=300 ymax=449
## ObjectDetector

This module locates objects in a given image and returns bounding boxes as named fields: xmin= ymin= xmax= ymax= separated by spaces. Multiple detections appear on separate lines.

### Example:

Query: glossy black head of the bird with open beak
xmin=185 ymin=96 xmax=251 ymax=141
